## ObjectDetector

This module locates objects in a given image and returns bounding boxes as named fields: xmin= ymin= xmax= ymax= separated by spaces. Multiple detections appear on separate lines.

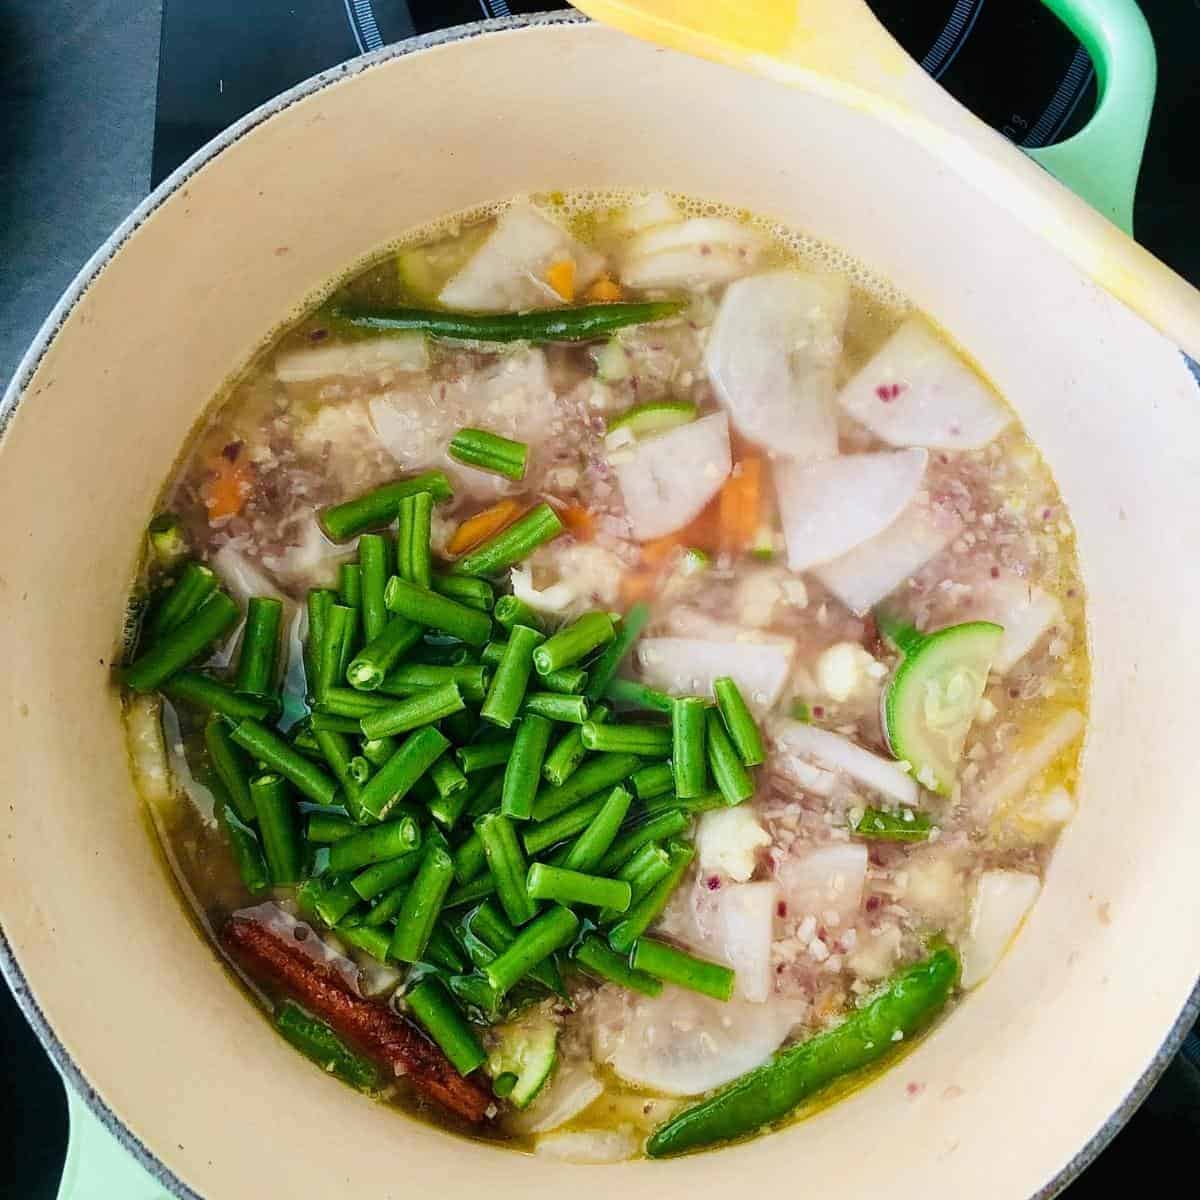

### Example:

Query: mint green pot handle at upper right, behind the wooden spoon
xmin=1026 ymin=0 xmax=1158 ymax=234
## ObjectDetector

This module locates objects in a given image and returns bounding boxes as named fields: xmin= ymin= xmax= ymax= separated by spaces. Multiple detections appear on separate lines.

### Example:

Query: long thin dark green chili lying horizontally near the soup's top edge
xmin=328 ymin=300 xmax=684 ymax=345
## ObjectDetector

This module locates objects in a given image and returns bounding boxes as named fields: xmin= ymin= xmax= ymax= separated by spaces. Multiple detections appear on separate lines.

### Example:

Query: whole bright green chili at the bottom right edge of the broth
xmin=646 ymin=946 xmax=959 ymax=1158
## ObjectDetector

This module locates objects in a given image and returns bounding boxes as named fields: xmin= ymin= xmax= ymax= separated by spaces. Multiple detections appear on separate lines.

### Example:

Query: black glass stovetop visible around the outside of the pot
xmin=0 ymin=0 xmax=1200 ymax=1200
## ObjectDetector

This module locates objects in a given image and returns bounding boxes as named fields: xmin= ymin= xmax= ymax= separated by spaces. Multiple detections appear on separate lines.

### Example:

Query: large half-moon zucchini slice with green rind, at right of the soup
xmin=882 ymin=620 xmax=1004 ymax=796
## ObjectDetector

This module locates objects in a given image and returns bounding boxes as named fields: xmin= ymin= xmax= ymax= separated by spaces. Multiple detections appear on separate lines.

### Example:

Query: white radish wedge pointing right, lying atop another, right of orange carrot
xmin=773 ymin=450 xmax=929 ymax=571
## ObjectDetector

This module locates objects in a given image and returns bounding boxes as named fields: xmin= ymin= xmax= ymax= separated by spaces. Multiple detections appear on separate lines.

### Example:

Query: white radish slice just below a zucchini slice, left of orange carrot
xmin=611 ymin=413 xmax=733 ymax=541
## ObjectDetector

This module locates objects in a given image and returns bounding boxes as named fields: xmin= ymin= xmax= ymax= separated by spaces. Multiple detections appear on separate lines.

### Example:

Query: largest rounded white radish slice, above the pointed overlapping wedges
xmin=704 ymin=270 xmax=850 ymax=462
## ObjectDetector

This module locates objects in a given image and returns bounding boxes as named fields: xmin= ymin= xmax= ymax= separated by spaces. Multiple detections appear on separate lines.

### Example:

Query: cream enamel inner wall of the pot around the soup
xmin=0 ymin=11 xmax=1200 ymax=1200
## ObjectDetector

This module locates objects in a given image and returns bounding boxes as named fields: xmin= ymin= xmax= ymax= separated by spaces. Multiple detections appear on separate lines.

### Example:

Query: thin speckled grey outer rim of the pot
xmin=0 ymin=10 xmax=1200 ymax=1200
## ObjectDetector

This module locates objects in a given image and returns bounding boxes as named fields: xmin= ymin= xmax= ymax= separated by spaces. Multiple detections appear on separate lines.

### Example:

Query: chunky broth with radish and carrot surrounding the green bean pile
xmin=121 ymin=193 xmax=1088 ymax=1160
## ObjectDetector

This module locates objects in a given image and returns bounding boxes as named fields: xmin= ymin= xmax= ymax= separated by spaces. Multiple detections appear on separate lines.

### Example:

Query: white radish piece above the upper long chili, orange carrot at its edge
xmin=438 ymin=204 xmax=604 ymax=312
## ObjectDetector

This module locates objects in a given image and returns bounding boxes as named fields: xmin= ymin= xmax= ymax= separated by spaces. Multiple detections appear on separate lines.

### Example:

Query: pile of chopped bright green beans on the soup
xmin=124 ymin=468 xmax=777 ymax=1086
